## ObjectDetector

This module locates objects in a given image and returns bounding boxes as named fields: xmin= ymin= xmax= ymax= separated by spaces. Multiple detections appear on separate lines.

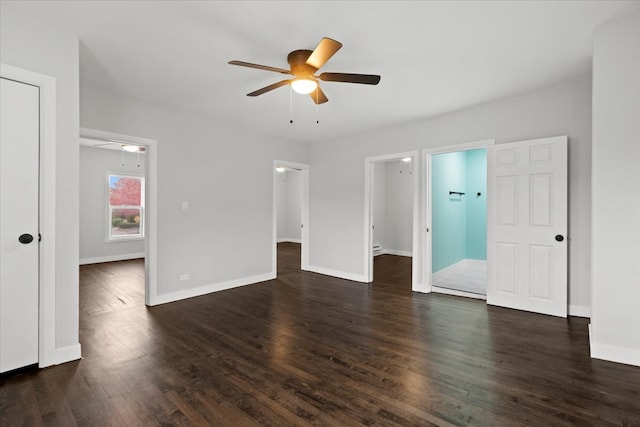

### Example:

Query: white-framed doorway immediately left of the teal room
xmin=364 ymin=151 xmax=419 ymax=289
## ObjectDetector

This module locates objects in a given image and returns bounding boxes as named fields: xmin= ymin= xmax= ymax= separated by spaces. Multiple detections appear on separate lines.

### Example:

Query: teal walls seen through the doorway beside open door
xmin=431 ymin=149 xmax=487 ymax=273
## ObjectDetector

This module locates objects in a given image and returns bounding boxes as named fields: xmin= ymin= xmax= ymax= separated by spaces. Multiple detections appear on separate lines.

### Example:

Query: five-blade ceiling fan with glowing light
xmin=229 ymin=37 xmax=380 ymax=104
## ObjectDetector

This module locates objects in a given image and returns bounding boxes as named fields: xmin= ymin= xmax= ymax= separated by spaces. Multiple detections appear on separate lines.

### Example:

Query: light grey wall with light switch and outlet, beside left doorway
xmin=80 ymin=88 xmax=313 ymax=302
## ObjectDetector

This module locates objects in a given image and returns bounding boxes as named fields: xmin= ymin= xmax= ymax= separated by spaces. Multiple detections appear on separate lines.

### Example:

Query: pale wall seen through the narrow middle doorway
xmin=275 ymin=169 xmax=302 ymax=243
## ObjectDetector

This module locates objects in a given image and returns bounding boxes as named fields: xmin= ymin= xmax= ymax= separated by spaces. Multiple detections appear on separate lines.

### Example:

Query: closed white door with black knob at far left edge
xmin=0 ymin=78 xmax=40 ymax=372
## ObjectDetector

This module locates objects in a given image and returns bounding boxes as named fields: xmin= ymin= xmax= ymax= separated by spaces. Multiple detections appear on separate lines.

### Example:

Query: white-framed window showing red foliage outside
xmin=107 ymin=175 xmax=144 ymax=241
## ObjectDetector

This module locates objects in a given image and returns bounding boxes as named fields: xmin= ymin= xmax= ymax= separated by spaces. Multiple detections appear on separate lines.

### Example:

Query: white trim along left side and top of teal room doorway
xmin=421 ymin=139 xmax=496 ymax=300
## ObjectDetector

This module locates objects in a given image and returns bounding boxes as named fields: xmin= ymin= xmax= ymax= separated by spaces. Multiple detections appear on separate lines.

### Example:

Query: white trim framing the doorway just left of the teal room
xmin=364 ymin=151 xmax=421 ymax=289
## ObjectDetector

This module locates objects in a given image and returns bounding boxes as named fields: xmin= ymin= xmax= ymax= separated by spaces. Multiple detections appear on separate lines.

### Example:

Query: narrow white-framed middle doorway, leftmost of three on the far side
xmin=272 ymin=160 xmax=309 ymax=277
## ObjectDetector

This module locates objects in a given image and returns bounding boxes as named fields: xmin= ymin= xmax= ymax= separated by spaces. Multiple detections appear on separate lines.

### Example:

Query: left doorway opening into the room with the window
xmin=79 ymin=138 xmax=147 ymax=314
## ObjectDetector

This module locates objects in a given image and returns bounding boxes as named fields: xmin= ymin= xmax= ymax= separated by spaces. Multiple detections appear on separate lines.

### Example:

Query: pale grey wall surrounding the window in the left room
xmin=80 ymin=146 xmax=145 ymax=264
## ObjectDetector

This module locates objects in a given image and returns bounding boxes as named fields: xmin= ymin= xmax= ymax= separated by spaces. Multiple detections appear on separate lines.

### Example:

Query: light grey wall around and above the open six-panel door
xmin=310 ymin=75 xmax=591 ymax=314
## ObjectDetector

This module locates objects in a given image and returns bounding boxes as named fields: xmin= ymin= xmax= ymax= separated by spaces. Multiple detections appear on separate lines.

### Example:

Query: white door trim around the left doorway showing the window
xmin=80 ymin=128 xmax=158 ymax=306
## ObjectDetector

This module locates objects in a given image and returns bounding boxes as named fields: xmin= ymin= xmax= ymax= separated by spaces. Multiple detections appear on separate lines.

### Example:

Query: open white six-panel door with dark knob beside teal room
xmin=487 ymin=136 xmax=567 ymax=317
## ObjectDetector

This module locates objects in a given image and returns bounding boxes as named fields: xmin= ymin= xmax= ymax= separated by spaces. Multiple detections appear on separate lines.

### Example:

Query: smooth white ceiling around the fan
xmin=1 ymin=0 xmax=640 ymax=142
